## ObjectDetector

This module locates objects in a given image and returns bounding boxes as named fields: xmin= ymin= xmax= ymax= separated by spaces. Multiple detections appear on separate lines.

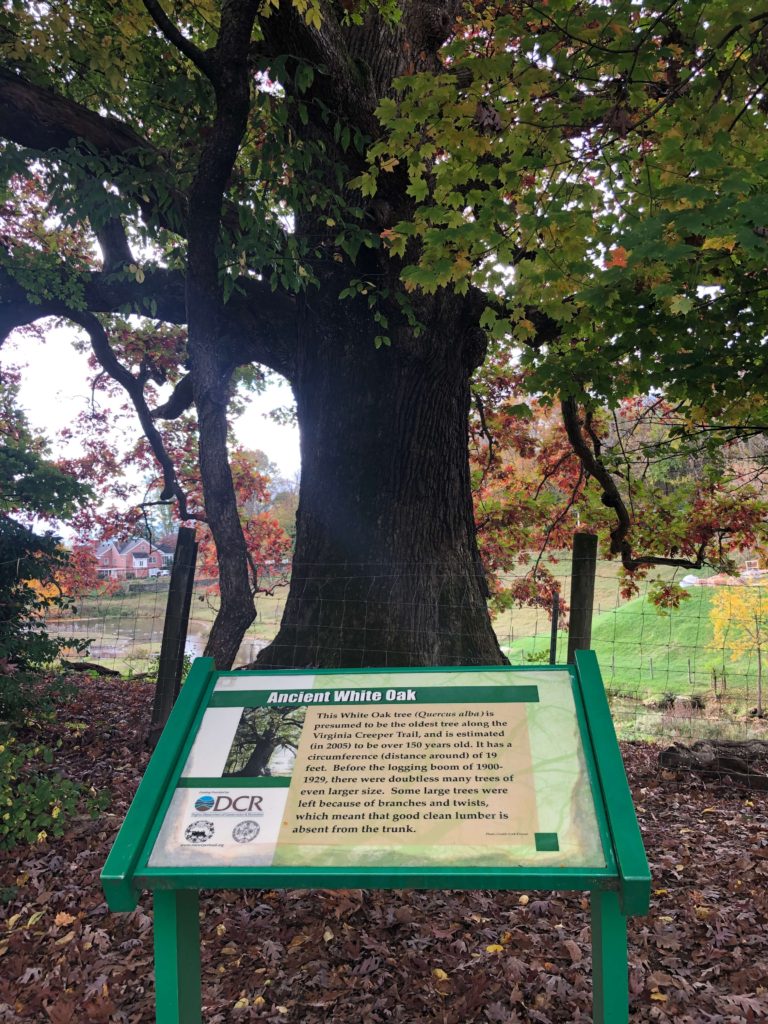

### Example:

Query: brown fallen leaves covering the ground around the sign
xmin=0 ymin=680 xmax=768 ymax=1024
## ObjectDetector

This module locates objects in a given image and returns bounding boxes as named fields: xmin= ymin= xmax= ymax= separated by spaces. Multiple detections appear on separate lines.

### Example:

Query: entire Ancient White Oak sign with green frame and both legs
xmin=101 ymin=651 xmax=650 ymax=1024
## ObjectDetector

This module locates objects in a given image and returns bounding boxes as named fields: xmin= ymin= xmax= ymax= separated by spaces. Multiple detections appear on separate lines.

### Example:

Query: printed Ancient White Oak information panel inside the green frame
xmin=148 ymin=670 xmax=606 ymax=868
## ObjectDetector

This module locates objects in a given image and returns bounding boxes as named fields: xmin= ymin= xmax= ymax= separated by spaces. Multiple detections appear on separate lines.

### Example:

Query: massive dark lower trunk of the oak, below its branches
xmin=256 ymin=288 xmax=505 ymax=668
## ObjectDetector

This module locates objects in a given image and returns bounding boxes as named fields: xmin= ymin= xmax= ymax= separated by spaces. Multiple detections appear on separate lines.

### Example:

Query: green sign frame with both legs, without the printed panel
xmin=101 ymin=651 xmax=650 ymax=1024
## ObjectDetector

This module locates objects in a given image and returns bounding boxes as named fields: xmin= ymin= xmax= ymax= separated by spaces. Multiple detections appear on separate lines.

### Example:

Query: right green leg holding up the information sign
xmin=590 ymin=892 xmax=630 ymax=1024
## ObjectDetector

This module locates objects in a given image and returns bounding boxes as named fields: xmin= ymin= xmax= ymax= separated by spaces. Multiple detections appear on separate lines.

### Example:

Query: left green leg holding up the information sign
xmin=155 ymin=890 xmax=202 ymax=1024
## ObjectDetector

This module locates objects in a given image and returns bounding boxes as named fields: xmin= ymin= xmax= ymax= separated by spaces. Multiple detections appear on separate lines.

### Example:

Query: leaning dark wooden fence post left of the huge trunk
xmin=147 ymin=526 xmax=198 ymax=749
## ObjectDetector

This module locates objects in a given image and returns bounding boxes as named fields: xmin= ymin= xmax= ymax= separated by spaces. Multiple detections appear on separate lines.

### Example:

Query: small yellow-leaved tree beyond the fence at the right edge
xmin=710 ymin=583 xmax=768 ymax=718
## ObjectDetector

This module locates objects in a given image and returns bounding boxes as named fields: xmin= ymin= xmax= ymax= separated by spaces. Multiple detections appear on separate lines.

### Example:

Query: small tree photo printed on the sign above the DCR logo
xmin=222 ymin=708 xmax=306 ymax=778
